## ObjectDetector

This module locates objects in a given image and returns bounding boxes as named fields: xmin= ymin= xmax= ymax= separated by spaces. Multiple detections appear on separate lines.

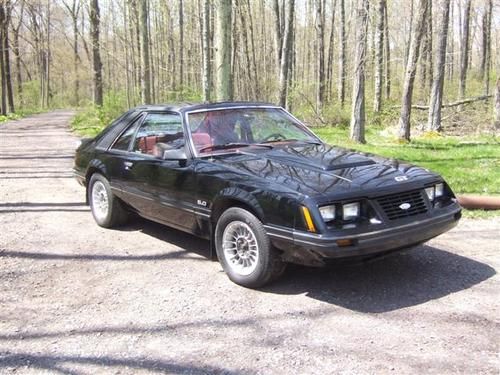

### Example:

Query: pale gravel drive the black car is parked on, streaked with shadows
xmin=0 ymin=111 xmax=500 ymax=374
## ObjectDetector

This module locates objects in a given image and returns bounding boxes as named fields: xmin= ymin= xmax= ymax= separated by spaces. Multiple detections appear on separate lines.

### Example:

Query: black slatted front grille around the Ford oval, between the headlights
xmin=375 ymin=190 xmax=427 ymax=220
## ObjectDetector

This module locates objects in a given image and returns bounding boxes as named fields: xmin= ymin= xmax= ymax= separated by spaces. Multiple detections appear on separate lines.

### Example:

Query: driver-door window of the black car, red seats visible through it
xmin=133 ymin=113 xmax=184 ymax=157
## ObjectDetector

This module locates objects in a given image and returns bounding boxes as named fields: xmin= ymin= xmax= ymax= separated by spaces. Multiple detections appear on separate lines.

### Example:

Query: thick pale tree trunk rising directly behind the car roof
xmin=214 ymin=0 xmax=233 ymax=101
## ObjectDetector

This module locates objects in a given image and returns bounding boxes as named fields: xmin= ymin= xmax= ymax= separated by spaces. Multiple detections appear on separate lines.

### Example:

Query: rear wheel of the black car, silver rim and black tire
xmin=88 ymin=173 xmax=128 ymax=228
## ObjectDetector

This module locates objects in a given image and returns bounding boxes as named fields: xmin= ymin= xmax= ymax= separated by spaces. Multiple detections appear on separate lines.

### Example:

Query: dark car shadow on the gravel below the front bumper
xmin=263 ymin=245 xmax=496 ymax=313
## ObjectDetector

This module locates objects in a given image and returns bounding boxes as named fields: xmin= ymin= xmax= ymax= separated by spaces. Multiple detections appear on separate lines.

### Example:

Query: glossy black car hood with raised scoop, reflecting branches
xmin=207 ymin=144 xmax=438 ymax=198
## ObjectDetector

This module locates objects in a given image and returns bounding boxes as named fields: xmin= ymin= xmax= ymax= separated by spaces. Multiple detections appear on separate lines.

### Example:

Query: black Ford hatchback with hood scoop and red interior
xmin=75 ymin=102 xmax=461 ymax=287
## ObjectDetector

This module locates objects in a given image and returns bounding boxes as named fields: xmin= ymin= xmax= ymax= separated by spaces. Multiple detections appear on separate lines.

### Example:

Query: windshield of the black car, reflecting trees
xmin=188 ymin=108 xmax=320 ymax=154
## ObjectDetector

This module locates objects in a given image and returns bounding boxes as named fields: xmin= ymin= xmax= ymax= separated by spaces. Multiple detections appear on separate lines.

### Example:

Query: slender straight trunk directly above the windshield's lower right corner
xmin=315 ymin=0 xmax=325 ymax=114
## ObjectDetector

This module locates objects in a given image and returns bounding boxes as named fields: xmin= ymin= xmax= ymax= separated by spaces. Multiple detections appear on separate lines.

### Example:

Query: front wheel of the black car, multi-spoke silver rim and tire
xmin=215 ymin=207 xmax=286 ymax=288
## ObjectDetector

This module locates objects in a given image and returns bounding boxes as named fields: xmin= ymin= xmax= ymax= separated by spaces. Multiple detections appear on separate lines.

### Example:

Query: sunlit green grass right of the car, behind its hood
xmin=313 ymin=127 xmax=500 ymax=195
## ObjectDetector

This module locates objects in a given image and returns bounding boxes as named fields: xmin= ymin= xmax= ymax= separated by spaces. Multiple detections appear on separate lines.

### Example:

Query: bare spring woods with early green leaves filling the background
xmin=0 ymin=0 xmax=500 ymax=142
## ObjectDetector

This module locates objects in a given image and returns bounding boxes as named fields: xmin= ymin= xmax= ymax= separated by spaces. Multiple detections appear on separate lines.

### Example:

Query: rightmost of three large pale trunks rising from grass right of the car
xmin=427 ymin=0 xmax=450 ymax=131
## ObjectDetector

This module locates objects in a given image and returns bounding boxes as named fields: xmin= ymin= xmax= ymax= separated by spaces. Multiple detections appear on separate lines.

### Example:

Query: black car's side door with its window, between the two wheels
xmin=127 ymin=112 xmax=196 ymax=232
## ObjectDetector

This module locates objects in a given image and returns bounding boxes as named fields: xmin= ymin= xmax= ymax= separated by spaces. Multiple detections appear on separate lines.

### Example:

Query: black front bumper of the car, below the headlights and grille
xmin=266 ymin=204 xmax=461 ymax=266
